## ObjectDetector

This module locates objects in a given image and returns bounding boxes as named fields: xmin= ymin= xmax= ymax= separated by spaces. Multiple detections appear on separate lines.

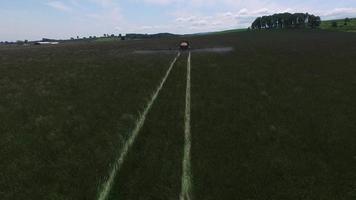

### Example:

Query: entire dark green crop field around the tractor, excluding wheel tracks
xmin=0 ymin=30 xmax=356 ymax=200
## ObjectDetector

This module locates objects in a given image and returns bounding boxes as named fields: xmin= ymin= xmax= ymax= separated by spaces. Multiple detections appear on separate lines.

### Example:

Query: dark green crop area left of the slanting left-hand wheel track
xmin=0 ymin=41 xmax=177 ymax=199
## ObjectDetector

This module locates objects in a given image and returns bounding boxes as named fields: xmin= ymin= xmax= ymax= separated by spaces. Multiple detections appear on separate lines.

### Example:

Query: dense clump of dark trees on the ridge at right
xmin=251 ymin=13 xmax=321 ymax=29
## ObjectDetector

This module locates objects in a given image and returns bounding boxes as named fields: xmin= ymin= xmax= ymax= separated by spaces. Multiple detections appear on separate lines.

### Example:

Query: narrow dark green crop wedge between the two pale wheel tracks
xmin=109 ymin=54 xmax=187 ymax=200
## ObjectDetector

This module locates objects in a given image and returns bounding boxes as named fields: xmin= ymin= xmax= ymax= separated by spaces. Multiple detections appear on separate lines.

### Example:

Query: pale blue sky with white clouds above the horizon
xmin=0 ymin=0 xmax=356 ymax=41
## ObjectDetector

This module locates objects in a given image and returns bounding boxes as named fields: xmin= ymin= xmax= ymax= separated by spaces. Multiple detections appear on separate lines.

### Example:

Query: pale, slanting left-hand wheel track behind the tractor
xmin=98 ymin=53 xmax=180 ymax=200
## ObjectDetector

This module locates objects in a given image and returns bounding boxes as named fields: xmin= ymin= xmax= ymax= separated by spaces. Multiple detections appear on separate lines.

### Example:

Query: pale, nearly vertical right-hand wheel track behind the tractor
xmin=179 ymin=52 xmax=192 ymax=200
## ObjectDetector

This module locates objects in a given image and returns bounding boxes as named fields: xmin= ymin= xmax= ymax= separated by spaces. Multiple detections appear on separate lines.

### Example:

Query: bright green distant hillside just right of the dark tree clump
xmin=320 ymin=18 xmax=356 ymax=32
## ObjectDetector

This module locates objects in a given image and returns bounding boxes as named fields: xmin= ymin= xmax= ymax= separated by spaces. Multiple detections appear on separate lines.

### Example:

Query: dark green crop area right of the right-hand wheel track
xmin=191 ymin=31 xmax=356 ymax=200
